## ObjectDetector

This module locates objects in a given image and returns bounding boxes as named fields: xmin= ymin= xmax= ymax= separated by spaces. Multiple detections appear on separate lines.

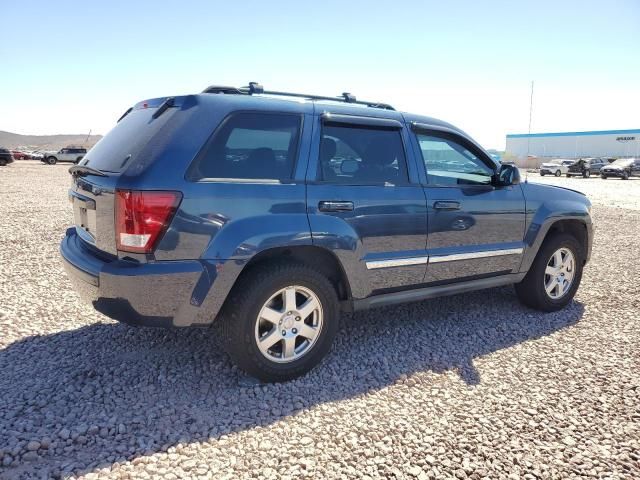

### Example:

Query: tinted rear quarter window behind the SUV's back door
xmin=187 ymin=112 xmax=302 ymax=181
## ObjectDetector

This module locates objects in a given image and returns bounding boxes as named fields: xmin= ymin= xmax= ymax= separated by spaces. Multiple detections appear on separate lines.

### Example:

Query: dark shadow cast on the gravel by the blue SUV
xmin=0 ymin=289 xmax=584 ymax=478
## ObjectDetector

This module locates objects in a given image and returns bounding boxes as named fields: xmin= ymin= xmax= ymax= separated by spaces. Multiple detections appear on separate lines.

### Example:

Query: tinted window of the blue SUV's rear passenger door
xmin=318 ymin=125 xmax=408 ymax=185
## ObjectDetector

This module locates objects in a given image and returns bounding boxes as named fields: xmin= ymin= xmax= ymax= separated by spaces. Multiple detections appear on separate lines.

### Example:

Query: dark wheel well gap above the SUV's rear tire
xmin=242 ymin=245 xmax=351 ymax=300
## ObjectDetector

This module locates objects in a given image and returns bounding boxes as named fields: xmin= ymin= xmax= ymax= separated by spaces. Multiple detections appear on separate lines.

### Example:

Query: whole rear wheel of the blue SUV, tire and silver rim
xmin=220 ymin=263 xmax=339 ymax=382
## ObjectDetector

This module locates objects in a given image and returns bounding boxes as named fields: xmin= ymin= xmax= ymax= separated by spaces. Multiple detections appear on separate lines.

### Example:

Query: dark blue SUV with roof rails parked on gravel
xmin=60 ymin=83 xmax=592 ymax=381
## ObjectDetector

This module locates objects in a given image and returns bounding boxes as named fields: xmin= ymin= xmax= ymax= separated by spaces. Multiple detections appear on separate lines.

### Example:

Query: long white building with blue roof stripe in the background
xmin=506 ymin=130 xmax=640 ymax=159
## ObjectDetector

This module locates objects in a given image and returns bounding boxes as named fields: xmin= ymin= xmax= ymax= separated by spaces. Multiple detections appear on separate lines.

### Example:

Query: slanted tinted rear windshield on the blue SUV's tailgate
xmin=82 ymin=108 xmax=175 ymax=173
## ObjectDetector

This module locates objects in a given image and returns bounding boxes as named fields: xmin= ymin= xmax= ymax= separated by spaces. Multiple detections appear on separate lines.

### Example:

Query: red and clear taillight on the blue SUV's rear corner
xmin=116 ymin=190 xmax=182 ymax=253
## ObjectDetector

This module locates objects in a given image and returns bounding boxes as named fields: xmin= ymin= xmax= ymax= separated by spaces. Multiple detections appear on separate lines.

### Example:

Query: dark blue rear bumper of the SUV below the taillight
xmin=60 ymin=228 xmax=211 ymax=327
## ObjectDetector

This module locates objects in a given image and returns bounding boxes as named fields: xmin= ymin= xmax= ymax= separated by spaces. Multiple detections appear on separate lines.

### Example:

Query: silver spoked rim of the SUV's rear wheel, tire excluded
xmin=255 ymin=285 xmax=323 ymax=363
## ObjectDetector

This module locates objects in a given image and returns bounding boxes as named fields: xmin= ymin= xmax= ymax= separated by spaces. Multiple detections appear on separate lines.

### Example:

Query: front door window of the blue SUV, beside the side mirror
xmin=417 ymin=134 xmax=494 ymax=186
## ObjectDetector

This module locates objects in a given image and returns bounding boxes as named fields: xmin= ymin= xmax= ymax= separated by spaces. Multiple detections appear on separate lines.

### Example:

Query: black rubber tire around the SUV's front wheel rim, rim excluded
xmin=515 ymin=233 xmax=584 ymax=312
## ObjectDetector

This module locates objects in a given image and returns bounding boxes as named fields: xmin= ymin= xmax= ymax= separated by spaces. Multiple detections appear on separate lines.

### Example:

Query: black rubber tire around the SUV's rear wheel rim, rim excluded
xmin=219 ymin=262 xmax=340 ymax=382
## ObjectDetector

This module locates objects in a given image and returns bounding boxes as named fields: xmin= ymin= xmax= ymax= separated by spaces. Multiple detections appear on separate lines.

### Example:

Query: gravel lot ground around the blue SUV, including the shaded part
xmin=0 ymin=162 xmax=640 ymax=479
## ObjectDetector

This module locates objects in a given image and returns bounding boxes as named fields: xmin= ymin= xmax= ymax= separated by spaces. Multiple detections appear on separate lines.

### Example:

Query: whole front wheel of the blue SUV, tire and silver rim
xmin=515 ymin=233 xmax=584 ymax=312
